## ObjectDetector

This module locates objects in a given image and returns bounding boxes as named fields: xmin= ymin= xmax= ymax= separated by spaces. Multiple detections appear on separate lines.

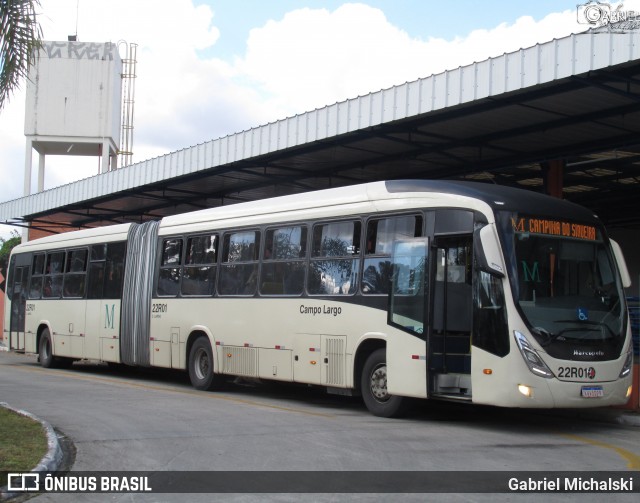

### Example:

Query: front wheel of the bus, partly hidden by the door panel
xmin=360 ymin=348 xmax=409 ymax=417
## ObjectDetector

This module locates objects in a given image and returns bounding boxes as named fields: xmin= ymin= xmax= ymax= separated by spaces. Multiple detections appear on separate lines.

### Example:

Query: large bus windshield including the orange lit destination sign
xmin=499 ymin=212 xmax=626 ymax=360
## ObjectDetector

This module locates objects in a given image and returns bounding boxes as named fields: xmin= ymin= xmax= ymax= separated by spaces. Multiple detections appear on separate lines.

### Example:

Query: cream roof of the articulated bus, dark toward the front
xmin=16 ymin=180 xmax=597 ymax=252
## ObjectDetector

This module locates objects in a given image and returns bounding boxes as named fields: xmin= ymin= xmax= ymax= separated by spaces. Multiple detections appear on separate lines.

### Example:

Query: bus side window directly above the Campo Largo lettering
xmin=307 ymin=220 xmax=361 ymax=295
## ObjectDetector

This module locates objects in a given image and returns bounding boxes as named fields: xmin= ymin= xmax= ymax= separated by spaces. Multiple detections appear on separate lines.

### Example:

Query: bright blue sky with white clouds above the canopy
xmin=0 ymin=0 xmax=640 ymax=239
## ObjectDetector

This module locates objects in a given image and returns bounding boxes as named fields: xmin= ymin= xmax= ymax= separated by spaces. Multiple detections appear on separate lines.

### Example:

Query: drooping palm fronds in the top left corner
xmin=0 ymin=0 xmax=42 ymax=110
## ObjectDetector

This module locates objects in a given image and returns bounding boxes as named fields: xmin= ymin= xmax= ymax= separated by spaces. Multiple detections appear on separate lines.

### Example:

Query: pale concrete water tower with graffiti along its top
xmin=24 ymin=41 xmax=123 ymax=195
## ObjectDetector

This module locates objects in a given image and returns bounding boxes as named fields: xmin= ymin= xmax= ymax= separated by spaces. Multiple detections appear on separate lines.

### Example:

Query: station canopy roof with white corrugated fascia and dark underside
xmin=0 ymin=27 xmax=640 ymax=232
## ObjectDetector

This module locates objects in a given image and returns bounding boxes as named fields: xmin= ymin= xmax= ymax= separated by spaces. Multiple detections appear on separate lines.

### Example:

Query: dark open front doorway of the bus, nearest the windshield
xmin=428 ymin=235 xmax=473 ymax=399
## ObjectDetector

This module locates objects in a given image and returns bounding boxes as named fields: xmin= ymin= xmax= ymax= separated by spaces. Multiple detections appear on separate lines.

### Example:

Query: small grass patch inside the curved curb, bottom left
xmin=0 ymin=407 xmax=48 ymax=487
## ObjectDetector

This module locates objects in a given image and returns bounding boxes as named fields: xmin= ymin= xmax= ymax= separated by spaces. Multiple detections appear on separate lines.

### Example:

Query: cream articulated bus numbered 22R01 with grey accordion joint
xmin=4 ymin=180 xmax=633 ymax=417
